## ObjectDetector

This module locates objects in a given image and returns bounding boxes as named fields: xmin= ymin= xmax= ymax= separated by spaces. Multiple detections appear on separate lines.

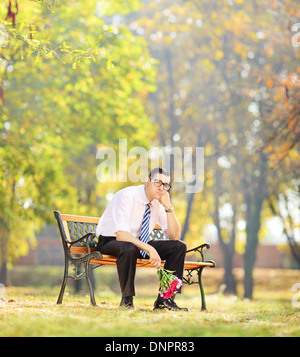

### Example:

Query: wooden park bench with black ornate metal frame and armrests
xmin=54 ymin=211 xmax=216 ymax=310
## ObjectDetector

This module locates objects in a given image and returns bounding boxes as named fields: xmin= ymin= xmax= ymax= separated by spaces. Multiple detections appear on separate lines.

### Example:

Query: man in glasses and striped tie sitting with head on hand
xmin=96 ymin=168 xmax=188 ymax=311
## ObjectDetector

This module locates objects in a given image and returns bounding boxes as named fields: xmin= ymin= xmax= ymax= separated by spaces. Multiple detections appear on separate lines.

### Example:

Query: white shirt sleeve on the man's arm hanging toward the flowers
xmin=112 ymin=192 xmax=131 ymax=234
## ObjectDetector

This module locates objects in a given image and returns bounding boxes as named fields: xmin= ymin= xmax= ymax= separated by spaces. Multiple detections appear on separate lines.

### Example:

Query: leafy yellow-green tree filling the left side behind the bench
xmin=0 ymin=0 xmax=155 ymax=283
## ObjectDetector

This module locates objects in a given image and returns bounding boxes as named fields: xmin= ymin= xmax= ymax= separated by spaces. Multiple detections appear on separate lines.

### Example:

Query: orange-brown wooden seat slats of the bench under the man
xmin=70 ymin=247 xmax=214 ymax=270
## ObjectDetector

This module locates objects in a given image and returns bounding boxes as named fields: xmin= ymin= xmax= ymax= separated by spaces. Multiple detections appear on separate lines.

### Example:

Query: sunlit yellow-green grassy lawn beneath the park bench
xmin=0 ymin=269 xmax=300 ymax=337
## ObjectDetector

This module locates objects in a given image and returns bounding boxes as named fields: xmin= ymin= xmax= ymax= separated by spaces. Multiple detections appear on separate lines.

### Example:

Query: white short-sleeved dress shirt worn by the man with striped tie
xmin=96 ymin=185 xmax=168 ymax=238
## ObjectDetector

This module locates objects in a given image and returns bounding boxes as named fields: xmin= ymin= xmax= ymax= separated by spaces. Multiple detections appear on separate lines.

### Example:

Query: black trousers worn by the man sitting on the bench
xmin=96 ymin=236 xmax=186 ymax=296
